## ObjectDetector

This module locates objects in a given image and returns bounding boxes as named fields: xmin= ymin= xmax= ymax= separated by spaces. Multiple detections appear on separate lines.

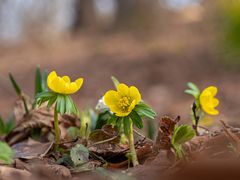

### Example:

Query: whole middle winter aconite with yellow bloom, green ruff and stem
xmin=103 ymin=77 xmax=156 ymax=166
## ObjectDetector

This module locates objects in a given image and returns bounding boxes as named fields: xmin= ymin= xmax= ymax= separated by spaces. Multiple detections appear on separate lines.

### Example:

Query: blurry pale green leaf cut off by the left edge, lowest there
xmin=0 ymin=141 xmax=15 ymax=164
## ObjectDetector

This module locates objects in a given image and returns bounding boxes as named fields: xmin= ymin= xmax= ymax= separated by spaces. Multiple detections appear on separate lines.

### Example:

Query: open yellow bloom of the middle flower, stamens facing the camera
xmin=104 ymin=84 xmax=141 ymax=117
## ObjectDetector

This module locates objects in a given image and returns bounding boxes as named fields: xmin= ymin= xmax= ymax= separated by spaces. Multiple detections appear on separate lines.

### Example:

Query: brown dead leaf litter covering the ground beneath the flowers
xmin=0 ymin=95 xmax=240 ymax=179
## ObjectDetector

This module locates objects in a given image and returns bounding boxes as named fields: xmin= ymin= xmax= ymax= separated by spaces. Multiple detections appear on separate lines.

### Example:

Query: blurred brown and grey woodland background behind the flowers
xmin=0 ymin=0 xmax=240 ymax=126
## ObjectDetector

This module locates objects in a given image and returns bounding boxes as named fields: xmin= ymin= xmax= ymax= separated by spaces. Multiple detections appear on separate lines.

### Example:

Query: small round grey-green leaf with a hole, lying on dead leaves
xmin=70 ymin=144 xmax=89 ymax=166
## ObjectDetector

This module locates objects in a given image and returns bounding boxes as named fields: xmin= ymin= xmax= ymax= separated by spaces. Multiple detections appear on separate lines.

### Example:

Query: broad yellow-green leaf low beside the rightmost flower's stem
xmin=171 ymin=125 xmax=195 ymax=146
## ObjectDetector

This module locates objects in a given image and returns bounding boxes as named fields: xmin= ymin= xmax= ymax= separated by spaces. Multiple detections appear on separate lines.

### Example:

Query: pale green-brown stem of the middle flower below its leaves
xmin=128 ymin=119 xmax=139 ymax=167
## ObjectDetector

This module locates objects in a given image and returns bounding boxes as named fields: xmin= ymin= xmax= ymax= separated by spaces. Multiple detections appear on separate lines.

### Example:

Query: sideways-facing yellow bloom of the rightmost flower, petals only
xmin=199 ymin=86 xmax=219 ymax=115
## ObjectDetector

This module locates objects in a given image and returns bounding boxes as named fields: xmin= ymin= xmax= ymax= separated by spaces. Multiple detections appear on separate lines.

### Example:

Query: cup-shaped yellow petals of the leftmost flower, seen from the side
xmin=47 ymin=71 xmax=83 ymax=94
